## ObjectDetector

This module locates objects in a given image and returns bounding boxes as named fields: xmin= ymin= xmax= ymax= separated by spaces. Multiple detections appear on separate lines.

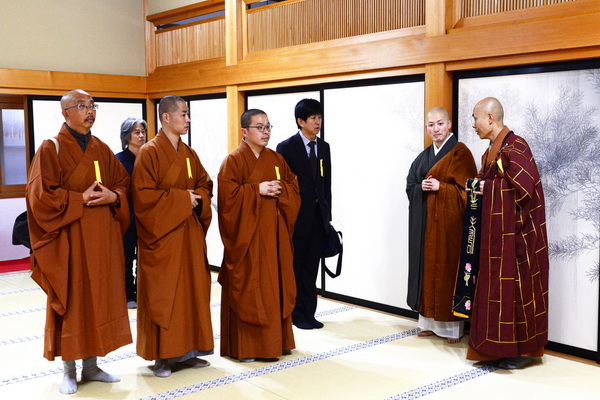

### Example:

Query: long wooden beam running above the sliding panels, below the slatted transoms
xmin=148 ymin=8 xmax=600 ymax=90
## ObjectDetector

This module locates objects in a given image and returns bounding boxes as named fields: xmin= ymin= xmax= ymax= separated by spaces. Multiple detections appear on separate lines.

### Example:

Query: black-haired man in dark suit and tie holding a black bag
xmin=277 ymin=99 xmax=331 ymax=329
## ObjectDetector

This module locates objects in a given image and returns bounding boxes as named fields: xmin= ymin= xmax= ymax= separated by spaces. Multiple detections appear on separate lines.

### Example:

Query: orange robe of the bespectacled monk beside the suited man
xmin=219 ymin=141 xmax=300 ymax=358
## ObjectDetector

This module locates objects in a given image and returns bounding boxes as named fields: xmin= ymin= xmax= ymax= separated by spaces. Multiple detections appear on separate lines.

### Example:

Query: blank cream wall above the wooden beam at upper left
xmin=0 ymin=0 xmax=146 ymax=76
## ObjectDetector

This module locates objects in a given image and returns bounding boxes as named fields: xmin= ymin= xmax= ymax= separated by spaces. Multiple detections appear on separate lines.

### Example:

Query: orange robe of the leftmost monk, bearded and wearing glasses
xmin=26 ymin=125 xmax=132 ymax=361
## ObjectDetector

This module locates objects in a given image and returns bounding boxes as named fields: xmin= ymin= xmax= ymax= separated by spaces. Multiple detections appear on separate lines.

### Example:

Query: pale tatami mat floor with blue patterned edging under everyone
xmin=0 ymin=273 xmax=600 ymax=400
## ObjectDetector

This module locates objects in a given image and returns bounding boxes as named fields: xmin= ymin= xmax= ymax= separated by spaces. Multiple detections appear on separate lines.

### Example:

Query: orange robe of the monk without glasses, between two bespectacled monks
xmin=132 ymin=131 xmax=214 ymax=360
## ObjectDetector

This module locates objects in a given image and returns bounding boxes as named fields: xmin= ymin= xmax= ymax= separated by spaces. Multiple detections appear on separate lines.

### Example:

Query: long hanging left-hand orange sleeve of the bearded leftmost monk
xmin=26 ymin=141 xmax=83 ymax=315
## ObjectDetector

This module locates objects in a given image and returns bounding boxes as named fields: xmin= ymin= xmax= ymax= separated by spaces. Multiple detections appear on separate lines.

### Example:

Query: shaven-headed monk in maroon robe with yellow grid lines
xmin=467 ymin=97 xmax=549 ymax=369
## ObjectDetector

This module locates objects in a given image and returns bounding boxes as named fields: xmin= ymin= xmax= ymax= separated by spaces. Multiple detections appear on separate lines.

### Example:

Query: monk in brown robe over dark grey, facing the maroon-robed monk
xmin=406 ymin=107 xmax=477 ymax=344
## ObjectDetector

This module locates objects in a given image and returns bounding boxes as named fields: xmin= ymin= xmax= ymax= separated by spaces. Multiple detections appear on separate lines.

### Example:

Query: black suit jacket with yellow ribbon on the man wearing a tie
xmin=277 ymin=132 xmax=331 ymax=236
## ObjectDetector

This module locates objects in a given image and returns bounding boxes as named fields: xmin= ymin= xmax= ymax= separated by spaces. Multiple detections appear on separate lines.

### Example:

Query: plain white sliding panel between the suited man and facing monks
xmin=324 ymin=82 xmax=424 ymax=309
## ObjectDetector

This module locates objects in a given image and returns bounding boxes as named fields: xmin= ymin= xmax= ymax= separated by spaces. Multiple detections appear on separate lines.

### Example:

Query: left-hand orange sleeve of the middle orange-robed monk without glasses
xmin=132 ymin=147 xmax=193 ymax=245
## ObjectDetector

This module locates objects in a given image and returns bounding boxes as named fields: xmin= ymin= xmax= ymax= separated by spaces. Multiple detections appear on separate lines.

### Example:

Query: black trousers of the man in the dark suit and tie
xmin=292 ymin=204 xmax=325 ymax=322
